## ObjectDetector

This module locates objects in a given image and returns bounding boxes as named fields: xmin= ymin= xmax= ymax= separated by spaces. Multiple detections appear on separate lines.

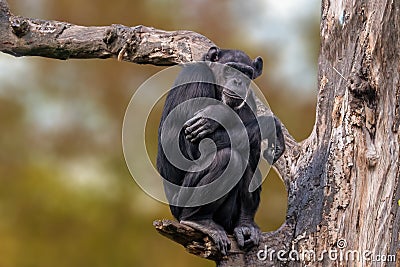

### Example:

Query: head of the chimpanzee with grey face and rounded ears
xmin=205 ymin=47 xmax=263 ymax=108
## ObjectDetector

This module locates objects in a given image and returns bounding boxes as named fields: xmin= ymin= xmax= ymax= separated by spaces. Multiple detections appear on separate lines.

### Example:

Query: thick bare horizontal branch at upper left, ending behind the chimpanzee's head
xmin=0 ymin=0 xmax=214 ymax=65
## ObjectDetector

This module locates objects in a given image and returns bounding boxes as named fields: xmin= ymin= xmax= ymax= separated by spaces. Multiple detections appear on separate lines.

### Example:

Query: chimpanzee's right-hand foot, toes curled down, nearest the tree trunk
xmin=233 ymin=223 xmax=261 ymax=249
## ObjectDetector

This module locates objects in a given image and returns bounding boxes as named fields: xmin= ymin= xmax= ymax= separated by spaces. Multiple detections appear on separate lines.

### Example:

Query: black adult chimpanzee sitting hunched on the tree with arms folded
xmin=157 ymin=47 xmax=285 ymax=254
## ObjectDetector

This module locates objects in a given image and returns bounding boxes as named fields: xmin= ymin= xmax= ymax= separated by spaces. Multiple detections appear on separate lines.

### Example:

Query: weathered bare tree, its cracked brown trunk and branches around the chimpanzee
xmin=0 ymin=0 xmax=400 ymax=266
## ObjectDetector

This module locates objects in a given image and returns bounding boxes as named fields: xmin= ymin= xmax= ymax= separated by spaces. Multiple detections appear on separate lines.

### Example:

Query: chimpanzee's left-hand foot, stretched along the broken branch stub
xmin=180 ymin=220 xmax=231 ymax=255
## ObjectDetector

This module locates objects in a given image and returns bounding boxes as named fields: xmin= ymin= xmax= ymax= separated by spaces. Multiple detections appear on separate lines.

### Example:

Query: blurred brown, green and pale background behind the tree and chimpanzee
xmin=0 ymin=0 xmax=320 ymax=267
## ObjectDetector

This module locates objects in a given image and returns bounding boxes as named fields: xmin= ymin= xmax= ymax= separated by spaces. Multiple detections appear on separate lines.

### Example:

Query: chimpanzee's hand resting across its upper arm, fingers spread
xmin=183 ymin=104 xmax=232 ymax=142
